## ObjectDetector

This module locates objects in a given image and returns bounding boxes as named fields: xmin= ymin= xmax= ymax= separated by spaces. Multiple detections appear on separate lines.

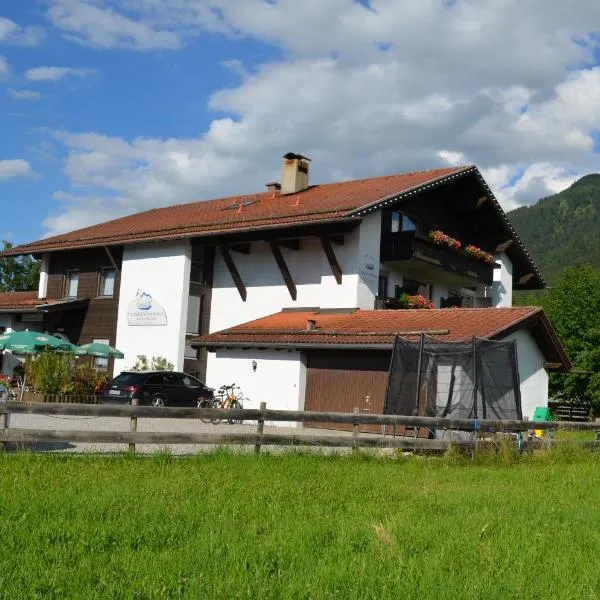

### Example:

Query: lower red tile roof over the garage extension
xmin=192 ymin=306 xmax=570 ymax=369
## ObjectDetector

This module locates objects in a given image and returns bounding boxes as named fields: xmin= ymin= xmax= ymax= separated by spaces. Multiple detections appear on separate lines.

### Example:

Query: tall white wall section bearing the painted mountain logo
xmin=114 ymin=240 xmax=191 ymax=374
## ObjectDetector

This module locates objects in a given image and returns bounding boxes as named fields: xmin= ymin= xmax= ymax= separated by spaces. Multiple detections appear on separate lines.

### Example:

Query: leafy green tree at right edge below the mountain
xmin=542 ymin=265 xmax=600 ymax=410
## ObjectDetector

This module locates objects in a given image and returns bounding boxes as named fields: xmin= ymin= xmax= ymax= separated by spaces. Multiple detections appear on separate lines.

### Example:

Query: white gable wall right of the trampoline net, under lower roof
xmin=505 ymin=329 xmax=548 ymax=419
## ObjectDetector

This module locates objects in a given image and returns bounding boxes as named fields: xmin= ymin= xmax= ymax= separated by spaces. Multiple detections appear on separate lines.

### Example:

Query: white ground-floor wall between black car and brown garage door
xmin=206 ymin=349 xmax=306 ymax=427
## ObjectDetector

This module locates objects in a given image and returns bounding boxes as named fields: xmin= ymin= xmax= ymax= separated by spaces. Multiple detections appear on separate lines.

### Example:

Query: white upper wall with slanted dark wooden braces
xmin=209 ymin=220 xmax=380 ymax=333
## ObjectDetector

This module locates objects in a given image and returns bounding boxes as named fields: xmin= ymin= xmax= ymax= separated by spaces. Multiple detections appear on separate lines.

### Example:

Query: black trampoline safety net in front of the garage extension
xmin=384 ymin=334 xmax=522 ymax=420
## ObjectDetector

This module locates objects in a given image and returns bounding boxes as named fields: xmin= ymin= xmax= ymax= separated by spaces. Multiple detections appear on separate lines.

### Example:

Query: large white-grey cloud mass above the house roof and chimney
xmin=41 ymin=0 xmax=600 ymax=237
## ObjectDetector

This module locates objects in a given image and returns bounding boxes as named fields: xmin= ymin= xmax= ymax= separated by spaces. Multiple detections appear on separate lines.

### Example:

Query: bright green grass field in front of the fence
xmin=0 ymin=449 xmax=600 ymax=600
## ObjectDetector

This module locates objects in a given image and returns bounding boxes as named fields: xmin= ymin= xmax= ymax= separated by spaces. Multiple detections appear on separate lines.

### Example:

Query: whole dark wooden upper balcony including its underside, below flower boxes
xmin=381 ymin=231 xmax=500 ymax=287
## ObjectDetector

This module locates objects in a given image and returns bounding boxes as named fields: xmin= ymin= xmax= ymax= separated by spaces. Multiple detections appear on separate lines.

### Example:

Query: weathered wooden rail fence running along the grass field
xmin=0 ymin=402 xmax=600 ymax=452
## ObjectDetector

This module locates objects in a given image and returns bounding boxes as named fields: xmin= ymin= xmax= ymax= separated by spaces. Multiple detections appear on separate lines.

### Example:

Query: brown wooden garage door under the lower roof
xmin=304 ymin=351 xmax=390 ymax=433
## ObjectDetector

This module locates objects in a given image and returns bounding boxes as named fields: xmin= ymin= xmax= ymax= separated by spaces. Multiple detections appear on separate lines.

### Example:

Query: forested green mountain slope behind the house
xmin=508 ymin=174 xmax=600 ymax=284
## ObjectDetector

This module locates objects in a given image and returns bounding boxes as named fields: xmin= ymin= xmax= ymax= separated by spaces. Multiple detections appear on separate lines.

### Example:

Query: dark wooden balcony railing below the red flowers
xmin=381 ymin=231 xmax=499 ymax=285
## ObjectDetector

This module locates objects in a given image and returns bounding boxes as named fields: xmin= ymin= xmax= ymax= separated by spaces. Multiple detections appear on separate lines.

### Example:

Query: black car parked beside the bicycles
xmin=102 ymin=371 xmax=213 ymax=406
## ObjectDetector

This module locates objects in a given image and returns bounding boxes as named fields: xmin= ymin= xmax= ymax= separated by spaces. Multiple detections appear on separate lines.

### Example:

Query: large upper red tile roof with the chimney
xmin=4 ymin=166 xmax=475 ymax=254
